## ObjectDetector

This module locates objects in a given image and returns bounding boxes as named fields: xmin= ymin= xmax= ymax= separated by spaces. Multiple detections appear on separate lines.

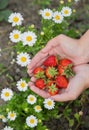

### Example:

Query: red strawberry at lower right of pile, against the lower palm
xmin=56 ymin=76 xmax=68 ymax=88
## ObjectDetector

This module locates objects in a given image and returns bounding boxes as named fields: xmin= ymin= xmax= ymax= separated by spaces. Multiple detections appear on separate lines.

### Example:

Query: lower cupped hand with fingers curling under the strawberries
xmin=29 ymin=64 xmax=89 ymax=102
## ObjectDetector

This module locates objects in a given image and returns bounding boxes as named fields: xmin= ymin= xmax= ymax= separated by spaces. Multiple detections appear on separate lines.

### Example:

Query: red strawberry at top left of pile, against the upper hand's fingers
xmin=43 ymin=55 xmax=57 ymax=66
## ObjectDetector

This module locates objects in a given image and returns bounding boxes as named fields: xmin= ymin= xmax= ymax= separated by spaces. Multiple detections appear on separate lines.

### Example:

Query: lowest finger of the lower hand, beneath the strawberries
xmin=29 ymin=83 xmax=50 ymax=98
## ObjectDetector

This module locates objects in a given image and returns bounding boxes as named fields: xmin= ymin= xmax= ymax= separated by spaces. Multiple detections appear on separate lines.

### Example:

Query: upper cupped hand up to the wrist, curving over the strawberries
xmin=28 ymin=34 xmax=86 ymax=75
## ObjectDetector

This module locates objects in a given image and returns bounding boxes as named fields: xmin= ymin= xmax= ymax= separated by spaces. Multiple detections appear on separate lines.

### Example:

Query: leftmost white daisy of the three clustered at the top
xmin=40 ymin=9 xmax=53 ymax=20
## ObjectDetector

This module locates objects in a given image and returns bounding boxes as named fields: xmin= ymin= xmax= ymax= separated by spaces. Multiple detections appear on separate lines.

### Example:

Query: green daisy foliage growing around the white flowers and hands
xmin=0 ymin=0 xmax=88 ymax=130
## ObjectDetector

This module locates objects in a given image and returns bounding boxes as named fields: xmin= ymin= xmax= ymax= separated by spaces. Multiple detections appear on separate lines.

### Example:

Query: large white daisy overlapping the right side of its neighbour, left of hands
xmin=21 ymin=31 xmax=37 ymax=46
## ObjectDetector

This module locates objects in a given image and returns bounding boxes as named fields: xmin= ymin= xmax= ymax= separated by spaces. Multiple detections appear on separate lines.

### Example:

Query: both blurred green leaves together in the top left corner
xmin=0 ymin=0 xmax=12 ymax=22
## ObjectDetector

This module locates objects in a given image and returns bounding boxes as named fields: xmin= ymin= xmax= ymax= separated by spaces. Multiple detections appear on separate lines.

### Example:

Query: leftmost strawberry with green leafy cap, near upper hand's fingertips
xmin=33 ymin=67 xmax=45 ymax=79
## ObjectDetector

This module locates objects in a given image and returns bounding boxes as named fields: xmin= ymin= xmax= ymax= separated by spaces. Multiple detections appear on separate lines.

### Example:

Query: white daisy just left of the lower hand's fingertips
xmin=16 ymin=79 xmax=28 ymax=91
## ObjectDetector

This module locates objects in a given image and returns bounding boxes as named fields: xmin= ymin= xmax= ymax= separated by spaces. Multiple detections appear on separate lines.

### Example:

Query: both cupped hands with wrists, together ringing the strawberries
xmin=28 ymin=30 xmax=89 ymax=101
